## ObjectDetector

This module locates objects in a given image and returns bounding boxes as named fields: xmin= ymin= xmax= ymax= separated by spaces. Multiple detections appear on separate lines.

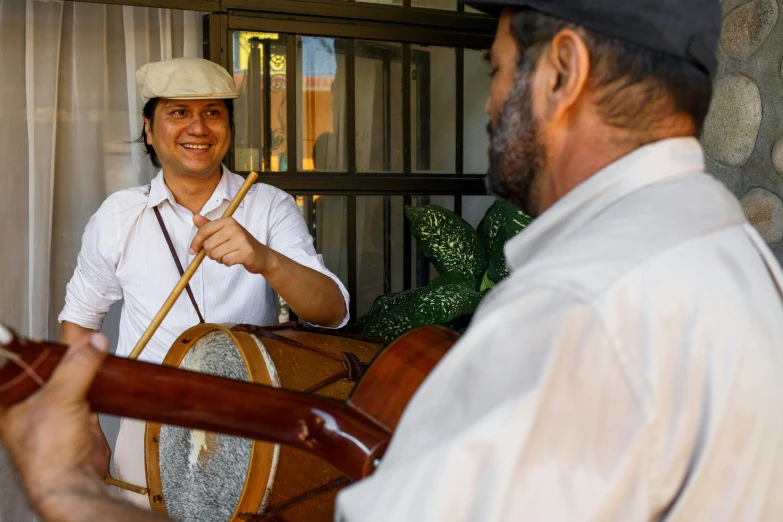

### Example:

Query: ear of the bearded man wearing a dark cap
xmin=539 ymin=29 xmax=590 ymax=120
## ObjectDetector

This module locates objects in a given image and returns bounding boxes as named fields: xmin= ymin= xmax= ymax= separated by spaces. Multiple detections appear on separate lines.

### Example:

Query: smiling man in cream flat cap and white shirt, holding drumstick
xmin=53 ymin=58 xmax=348 ymax=505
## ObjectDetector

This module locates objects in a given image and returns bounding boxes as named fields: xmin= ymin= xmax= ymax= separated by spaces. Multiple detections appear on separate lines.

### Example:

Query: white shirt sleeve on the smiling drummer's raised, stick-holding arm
xmin=267 ymin=191 xmax=350 ymax=328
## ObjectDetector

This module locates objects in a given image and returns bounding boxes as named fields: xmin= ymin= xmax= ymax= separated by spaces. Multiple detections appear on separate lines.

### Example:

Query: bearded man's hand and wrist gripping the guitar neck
xmin=0 ymin=334 xmax=163 ymax=522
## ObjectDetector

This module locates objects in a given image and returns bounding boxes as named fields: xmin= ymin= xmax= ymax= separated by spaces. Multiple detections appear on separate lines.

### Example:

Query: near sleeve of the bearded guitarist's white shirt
xmin=337 ymin=284 xmax=649 ymax=522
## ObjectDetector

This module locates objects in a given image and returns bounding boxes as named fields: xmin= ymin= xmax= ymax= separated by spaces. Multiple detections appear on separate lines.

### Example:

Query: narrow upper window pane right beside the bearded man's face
xmin=462 ymin=49 xmax=492 ymax=174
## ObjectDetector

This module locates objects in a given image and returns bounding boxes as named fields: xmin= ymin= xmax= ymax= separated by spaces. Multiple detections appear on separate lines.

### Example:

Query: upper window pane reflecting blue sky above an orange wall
xmin=296 ymin=36 xmax=348 ymax=172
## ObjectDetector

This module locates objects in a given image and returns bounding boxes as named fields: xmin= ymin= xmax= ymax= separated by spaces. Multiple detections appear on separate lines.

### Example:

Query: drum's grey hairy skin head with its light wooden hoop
xmin=146 ymin=325 xmax=279 ymax=522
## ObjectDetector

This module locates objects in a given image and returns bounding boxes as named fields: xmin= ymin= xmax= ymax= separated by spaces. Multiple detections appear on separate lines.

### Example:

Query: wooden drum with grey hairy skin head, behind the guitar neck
xmin=144 ymin=324 xmax=382 ymax=522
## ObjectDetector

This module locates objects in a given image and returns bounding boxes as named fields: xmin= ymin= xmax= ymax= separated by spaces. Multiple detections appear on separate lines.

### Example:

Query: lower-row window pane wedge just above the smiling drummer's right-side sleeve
xmin=296 ymin=195 xmax=348 ymax=288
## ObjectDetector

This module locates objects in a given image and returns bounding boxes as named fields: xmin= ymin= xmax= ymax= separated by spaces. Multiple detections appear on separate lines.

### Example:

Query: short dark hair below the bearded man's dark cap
xmin=511 ymin=9 xmax=712 ymax=135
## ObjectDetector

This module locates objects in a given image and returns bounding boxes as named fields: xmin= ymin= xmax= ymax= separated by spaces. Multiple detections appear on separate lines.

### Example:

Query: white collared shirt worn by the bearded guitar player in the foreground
xmin=338 ymin=138 xmax=783 ymax=522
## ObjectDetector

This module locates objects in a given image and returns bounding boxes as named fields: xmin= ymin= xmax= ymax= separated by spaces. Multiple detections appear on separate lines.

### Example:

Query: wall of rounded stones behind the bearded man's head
xmin=694 ymin=0 xmax=783 ymax=262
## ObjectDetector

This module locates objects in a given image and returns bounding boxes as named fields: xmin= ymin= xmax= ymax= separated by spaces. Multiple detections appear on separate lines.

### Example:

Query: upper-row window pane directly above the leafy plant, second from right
xmin=411 ymin=45 xmax=457 ymax=173
